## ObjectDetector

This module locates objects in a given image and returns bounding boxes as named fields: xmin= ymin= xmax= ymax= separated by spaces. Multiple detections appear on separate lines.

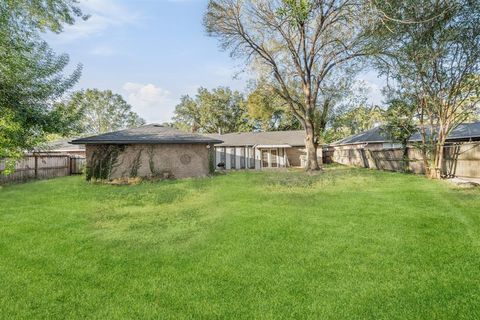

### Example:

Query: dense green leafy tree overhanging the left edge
xmin=0 ymin=0 xmax=87 ymax=172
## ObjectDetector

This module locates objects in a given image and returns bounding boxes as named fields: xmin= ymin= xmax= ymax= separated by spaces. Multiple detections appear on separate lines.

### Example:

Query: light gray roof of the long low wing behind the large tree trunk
xmin=208 ymin=130 xmax=305 ymax=147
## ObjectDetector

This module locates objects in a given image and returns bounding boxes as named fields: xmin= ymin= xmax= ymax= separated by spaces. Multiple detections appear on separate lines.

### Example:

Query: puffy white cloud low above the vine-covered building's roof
xmin=123 ymin=82 xmax=177 ymax=123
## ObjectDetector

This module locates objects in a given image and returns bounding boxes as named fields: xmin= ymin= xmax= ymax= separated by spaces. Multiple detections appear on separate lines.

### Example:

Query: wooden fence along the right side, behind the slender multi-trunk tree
xmin=329 ymin=142 xmax=480 ymax=178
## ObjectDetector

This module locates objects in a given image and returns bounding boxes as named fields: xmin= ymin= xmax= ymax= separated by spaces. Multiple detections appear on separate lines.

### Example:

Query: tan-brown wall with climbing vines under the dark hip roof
xmin=86 ymin=144 xmax=210 ymax=180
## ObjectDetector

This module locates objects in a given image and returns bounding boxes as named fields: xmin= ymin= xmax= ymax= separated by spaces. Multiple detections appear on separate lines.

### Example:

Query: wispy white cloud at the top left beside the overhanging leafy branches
xmin=55 ymin=0 xmax=138 ymax=42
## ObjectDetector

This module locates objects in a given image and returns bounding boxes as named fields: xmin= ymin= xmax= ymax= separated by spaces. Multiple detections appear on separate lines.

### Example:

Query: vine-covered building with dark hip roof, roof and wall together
xmin=71 ymin=124 xmax=222 ymax=180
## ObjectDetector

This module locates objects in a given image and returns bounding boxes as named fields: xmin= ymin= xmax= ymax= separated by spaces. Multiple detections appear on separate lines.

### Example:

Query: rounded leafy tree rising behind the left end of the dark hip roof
xmin=58 ymin=89 xmax=145 ymax=134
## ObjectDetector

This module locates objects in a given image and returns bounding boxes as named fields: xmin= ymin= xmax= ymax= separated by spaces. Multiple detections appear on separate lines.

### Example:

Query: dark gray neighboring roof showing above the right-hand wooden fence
xmin=332 ymin=122 xmax=480 ymax=145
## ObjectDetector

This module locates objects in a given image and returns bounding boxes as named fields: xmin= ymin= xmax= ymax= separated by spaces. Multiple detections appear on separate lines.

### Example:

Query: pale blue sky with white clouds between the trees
xmin=45 ymin=0 xmax=382 ymax=123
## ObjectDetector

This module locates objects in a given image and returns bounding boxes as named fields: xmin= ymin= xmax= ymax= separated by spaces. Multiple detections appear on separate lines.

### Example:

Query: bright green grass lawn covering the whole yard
xmin=0 ymin=166 xmax=480 ymax=319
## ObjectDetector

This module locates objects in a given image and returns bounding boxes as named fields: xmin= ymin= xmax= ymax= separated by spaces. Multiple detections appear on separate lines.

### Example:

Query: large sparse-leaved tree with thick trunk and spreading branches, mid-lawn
xmin=204 ymin=0 xmax=374 ymax=170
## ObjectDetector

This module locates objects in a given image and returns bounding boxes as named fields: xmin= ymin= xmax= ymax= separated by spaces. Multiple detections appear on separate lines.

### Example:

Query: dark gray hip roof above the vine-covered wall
xmin=70 ymin=124 xmax=222 ymax=144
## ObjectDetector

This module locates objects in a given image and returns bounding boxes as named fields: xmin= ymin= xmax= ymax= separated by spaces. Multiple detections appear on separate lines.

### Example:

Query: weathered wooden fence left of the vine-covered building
xmin=0 ymin=154 xmax=85 ymax=184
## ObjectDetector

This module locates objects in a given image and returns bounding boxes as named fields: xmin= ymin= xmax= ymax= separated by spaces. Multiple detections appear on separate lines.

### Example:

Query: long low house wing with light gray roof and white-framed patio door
xmin=208 ymin=130 xmax=322 ymax=169
